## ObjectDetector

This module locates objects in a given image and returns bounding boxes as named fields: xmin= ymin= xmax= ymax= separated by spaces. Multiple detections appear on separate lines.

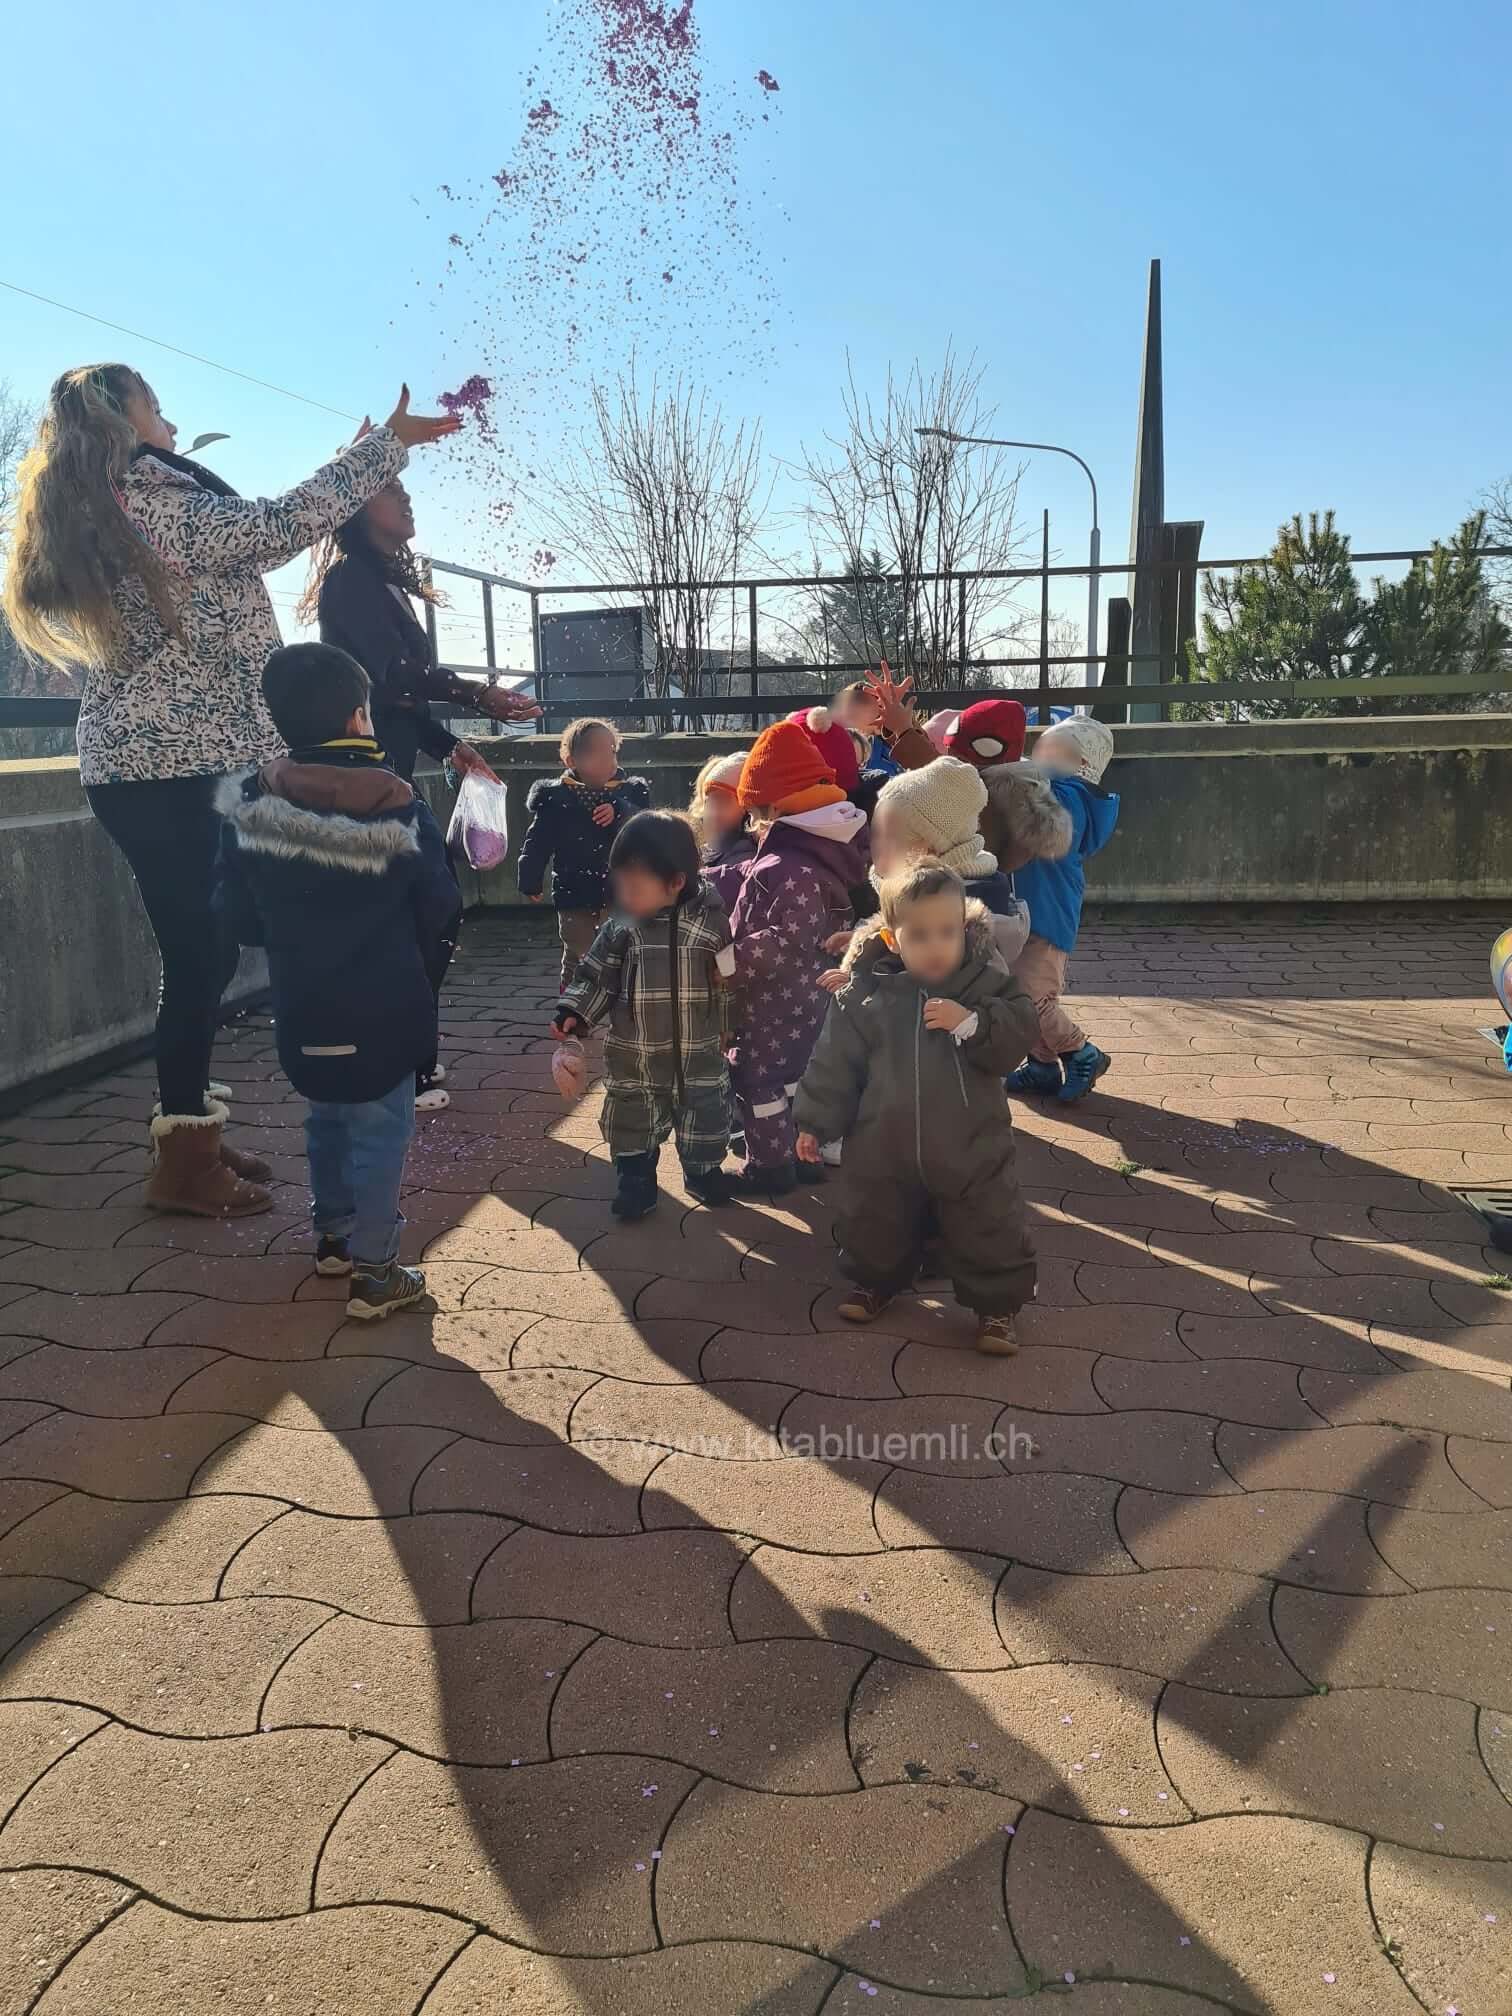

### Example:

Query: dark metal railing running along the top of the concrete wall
xmin=0 ymin=540 xmax=1512 ymax=745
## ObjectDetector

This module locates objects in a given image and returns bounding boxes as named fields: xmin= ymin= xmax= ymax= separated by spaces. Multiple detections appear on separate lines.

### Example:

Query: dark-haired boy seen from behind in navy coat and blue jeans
xmin=218 ymin=643 xmax=458 ymax=1320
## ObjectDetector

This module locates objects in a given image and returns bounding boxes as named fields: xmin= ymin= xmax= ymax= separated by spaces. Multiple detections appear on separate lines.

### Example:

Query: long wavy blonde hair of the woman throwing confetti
xmin=4 ymin=365 xmax=179 ymax=667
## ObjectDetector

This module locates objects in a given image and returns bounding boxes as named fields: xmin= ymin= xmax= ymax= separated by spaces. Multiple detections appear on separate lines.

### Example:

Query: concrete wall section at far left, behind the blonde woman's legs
xmin=0 ymin=756 xmax=266 ymax=1104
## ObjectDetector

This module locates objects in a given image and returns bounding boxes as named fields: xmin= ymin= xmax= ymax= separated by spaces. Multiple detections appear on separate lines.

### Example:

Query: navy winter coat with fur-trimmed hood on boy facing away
xmin=216 ymin=742 xmax=460 ymax=1103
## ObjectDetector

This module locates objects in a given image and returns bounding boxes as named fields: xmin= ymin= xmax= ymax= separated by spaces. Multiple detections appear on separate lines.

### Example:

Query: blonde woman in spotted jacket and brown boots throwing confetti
xmin=4 ymin=365 xmax=458 ymax=1218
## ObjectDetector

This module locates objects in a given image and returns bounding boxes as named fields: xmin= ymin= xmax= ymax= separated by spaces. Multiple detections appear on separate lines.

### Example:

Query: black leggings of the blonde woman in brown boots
xmin=85 ymin=776 xmax=238 ymax=1113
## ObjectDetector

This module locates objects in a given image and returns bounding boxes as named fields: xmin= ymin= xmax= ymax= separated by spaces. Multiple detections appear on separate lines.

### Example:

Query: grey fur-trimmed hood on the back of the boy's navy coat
xmin=216 ymin=758 xmax=419 ymax=875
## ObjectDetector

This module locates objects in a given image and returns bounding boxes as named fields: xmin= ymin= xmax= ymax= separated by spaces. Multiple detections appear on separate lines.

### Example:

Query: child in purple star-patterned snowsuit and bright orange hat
xmin=730 ymin=722 xmax=867 ymax=1198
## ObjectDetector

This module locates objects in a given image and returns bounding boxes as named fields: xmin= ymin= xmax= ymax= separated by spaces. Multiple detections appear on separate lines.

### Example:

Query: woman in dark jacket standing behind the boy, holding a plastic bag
xmin=298 ymin=476 xmax=540 ymax=1113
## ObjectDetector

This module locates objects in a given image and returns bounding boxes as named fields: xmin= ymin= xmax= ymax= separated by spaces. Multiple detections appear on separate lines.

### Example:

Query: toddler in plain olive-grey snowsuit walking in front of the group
xmin=794 ymin=861 xmax=1036 ymax=1357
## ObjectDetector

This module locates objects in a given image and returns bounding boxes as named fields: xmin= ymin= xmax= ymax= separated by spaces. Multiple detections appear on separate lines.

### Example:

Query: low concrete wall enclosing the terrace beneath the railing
xmin=0 ymin=714 xmax=1512 ymax=1097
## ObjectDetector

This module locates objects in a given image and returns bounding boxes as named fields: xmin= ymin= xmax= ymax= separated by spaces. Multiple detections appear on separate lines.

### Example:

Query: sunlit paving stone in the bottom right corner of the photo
xmin=1371 ymin=1841 xmax=1512 ymax=2016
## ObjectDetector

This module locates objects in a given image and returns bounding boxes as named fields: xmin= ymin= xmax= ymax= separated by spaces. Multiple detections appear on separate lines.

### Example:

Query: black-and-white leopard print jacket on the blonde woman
xmin=79 ymin=427 xmax=409 ymax=784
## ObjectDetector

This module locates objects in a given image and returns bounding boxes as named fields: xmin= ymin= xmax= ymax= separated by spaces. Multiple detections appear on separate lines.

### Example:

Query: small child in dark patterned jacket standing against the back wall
xmin=514 ymin=720 xmax=651 ymax=994
